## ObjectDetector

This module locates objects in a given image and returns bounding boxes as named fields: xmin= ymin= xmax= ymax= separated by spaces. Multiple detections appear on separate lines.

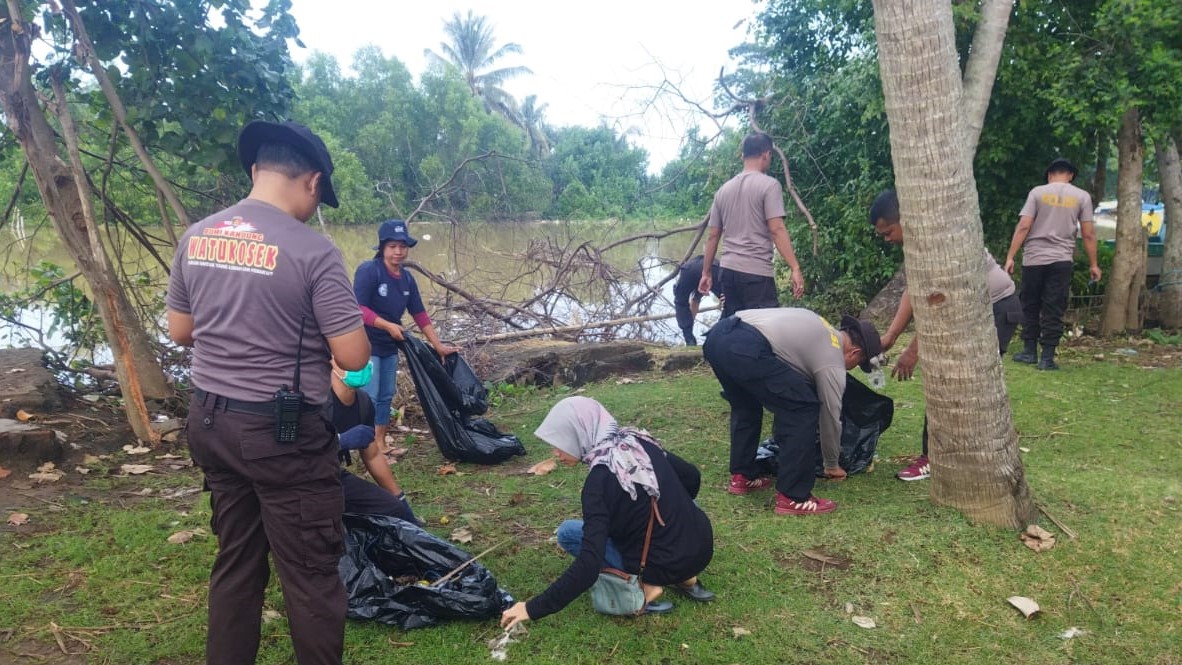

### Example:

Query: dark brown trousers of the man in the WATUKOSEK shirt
xmin=188 ymin=395 xmax=345 ymax=665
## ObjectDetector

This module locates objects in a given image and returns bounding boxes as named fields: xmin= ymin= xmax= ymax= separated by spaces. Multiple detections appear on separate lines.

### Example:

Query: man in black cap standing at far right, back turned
xmin=1005 ymin=157 xmax=1100 ymax=370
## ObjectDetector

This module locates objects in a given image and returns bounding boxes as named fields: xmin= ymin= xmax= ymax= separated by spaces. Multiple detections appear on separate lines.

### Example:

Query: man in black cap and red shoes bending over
xmin=702 ymin=307 xmax=882 ymax=515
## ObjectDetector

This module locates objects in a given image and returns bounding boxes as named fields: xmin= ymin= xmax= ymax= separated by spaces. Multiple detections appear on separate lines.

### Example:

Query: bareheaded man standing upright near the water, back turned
xmin=697 ymin=131 xmax=805 ymax=317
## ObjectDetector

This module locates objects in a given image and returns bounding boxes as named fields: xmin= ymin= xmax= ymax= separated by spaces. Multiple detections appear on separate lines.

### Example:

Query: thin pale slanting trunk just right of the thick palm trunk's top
xmin=962 ymin=0 xmax=1014 ymax=159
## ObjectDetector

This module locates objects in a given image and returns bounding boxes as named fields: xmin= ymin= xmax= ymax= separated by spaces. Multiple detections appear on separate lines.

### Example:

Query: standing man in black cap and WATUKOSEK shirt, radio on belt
xmin=168 ymin=122 xmax=370 ymax=665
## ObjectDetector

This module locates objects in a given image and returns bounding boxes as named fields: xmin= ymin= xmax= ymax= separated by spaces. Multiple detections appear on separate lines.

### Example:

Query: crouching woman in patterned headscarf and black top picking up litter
xmin=501 ymin=397 xmax=714 ymax=628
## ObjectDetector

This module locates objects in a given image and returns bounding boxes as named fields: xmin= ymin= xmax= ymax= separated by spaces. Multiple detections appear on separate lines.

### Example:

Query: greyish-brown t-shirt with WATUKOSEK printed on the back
xmin=167 ymin=198 xmax=362 ymax=404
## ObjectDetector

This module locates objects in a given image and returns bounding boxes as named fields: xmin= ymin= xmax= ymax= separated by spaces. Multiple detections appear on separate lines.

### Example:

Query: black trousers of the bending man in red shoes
xmin=702 ymin=317 xmax=820 ymax=501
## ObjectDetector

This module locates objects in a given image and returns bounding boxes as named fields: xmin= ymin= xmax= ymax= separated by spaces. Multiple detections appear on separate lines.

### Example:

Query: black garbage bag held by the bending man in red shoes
xmin=755 ymin=374 xmax=895 ymax=477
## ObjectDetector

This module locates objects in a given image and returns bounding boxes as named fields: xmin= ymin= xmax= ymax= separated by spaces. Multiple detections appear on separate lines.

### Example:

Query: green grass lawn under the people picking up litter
xmin=0 ymin=348 xmax=1182 ymax=665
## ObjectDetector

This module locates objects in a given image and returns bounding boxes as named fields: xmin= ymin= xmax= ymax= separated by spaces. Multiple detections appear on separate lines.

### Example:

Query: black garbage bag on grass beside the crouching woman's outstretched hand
xmin=339 ymin=513 xmax=513 ymax=631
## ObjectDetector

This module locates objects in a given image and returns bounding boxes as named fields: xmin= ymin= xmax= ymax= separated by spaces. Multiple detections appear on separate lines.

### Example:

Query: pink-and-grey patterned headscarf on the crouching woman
xmin=533 ymin=397 xmax=661 ymax=501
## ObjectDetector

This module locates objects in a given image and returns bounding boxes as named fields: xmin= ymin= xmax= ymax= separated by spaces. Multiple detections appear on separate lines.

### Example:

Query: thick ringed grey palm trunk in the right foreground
xmin=875 ymin=0 xmax=1035 ymax=528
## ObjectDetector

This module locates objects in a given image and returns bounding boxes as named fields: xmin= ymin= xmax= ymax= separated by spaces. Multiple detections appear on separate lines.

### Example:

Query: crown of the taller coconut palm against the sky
xmin=423 ymin=9 xmax=533 ymax=124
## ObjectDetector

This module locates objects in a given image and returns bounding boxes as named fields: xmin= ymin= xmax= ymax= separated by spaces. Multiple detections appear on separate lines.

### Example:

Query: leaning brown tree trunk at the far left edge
xmin=0 ymin=9 xmax=173 ymax=442
